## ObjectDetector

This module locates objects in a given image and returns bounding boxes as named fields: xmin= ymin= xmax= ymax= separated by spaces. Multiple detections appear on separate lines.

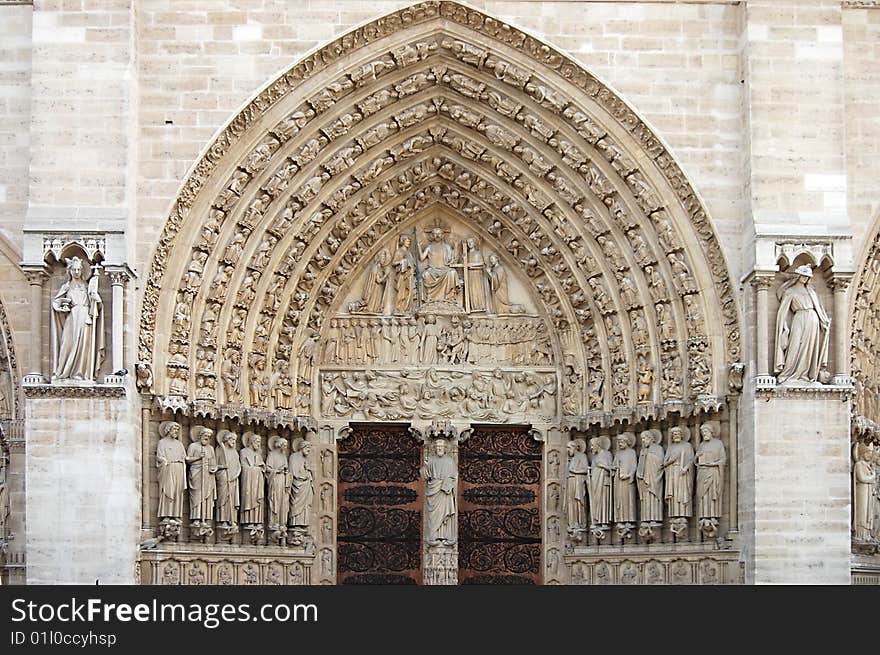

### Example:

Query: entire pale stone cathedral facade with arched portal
xmin=0 ymin=0 xmax=880 ymax=585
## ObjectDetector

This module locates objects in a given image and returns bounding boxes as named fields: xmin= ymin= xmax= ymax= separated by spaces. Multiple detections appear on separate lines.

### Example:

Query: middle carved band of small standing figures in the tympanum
xmin=322 ymin=315 xmax=553 ymax=366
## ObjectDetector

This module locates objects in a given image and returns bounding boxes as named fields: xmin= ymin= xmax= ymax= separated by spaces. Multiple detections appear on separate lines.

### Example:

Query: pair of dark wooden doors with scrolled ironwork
xmin=337 ymin=424 xmax=542 ymax=584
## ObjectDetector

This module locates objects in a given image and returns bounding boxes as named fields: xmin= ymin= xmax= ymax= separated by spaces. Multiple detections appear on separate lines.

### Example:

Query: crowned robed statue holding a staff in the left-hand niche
xmin=52 ymin=257 xmax=105 ymax=382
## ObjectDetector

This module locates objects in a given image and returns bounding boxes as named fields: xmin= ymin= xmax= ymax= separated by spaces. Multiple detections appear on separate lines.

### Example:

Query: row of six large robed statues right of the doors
xmin=564 ymin=421 xmax=727 ymax=543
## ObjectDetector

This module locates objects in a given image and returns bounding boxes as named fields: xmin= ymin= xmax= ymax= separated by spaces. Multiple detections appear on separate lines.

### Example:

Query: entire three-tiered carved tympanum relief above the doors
xmin=318 ymin=218 xmax=558 ymax=421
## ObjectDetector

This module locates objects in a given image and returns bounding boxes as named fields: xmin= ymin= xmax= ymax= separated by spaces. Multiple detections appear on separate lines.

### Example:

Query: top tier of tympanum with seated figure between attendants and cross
xmin=343 ymin=218 xmax=535 ymax=317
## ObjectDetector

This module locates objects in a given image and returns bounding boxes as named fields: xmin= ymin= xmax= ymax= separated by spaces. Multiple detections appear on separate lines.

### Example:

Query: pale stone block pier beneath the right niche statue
xmin=740 ymin=385 xmax=851 ymax=584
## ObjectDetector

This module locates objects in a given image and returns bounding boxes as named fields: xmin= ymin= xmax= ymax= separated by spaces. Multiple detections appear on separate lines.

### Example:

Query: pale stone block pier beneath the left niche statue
xmin=25 ymin=377 xmax=141 ymax=584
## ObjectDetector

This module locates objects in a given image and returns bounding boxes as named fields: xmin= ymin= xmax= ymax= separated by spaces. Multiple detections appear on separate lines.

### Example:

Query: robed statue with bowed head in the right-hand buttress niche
xmin=774 ymin=265 xmax=831 ymax=383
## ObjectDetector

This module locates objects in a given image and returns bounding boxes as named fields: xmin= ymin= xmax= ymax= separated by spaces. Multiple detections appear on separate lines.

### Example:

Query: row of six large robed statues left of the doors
xmin=156 ymin=421 xmax=320 ymax=546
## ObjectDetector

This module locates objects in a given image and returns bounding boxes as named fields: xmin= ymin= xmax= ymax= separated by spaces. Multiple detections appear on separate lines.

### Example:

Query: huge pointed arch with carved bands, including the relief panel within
xmin=139 ymin=2 xmax=740 ymax=581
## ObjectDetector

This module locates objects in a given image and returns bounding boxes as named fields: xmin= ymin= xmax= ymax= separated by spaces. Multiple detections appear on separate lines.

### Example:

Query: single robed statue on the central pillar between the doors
xmin=421 ymin=439 xmax=458 ymax=546
